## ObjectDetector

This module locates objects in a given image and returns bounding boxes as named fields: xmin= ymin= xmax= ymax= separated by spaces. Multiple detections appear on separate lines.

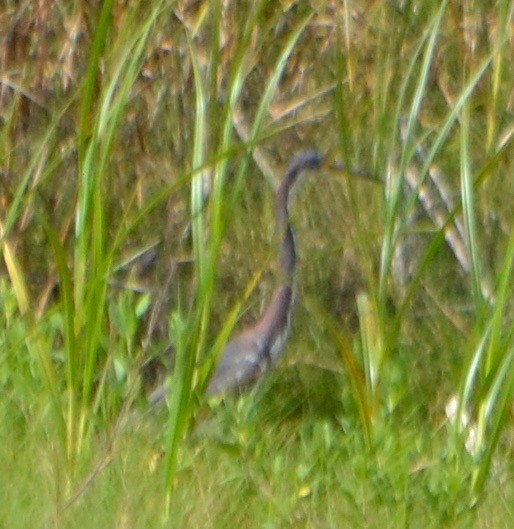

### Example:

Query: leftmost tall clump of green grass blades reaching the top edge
xmin=64 ymin=2 xmax=163 ymax=453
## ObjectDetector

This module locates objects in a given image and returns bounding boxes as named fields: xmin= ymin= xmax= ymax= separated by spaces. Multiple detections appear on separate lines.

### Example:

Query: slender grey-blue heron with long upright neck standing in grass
xmin=149 ymin=151 xmax=364 ymax=403
